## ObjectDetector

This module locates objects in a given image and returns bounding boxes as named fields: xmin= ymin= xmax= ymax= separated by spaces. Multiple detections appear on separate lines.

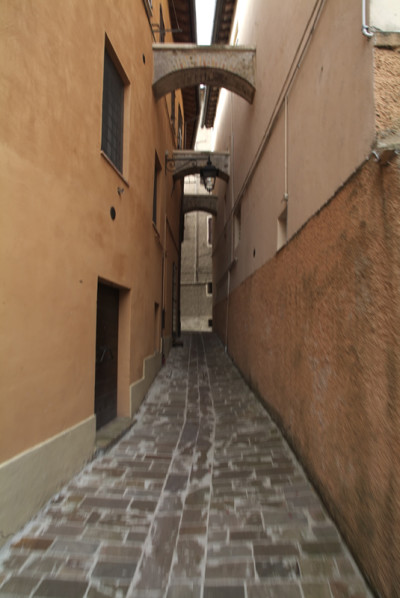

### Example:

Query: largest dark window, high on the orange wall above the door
xmin=101 ymin=46 xmax=125 ymax=172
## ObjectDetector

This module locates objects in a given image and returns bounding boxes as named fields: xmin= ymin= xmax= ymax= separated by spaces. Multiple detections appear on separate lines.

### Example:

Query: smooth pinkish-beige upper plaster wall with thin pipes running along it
xmin=214 ymin=0 xmax=375 ymax=298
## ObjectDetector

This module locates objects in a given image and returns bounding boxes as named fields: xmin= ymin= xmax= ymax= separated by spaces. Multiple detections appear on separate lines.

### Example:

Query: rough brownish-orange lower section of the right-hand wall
xmin=214 ymin=159 xmax=400 ymax=597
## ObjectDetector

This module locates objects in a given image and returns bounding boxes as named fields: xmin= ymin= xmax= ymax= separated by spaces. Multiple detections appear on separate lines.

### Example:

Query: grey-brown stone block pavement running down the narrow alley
xmin=0 ymin=334 xmax=370 ymax=598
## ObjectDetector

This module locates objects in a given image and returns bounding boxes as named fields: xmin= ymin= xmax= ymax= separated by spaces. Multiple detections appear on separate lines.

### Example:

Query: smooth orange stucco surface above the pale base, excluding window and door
xmin=0 ymin=0 xmax=181 ymax=463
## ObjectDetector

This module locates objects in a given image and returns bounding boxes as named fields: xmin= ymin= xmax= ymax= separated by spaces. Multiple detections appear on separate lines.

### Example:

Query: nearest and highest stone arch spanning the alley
xmin=153 ymin=44 xmax=255 ymax=104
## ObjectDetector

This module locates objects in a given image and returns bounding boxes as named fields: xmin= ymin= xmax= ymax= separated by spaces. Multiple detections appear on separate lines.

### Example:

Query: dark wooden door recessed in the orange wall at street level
xmin=94 ymin=283 xmax=119 ymax=430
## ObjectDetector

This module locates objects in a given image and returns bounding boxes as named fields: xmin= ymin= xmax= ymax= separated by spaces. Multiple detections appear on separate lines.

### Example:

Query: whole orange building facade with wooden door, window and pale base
xmin=0 ymin=0 xmax=198 ymax=542
